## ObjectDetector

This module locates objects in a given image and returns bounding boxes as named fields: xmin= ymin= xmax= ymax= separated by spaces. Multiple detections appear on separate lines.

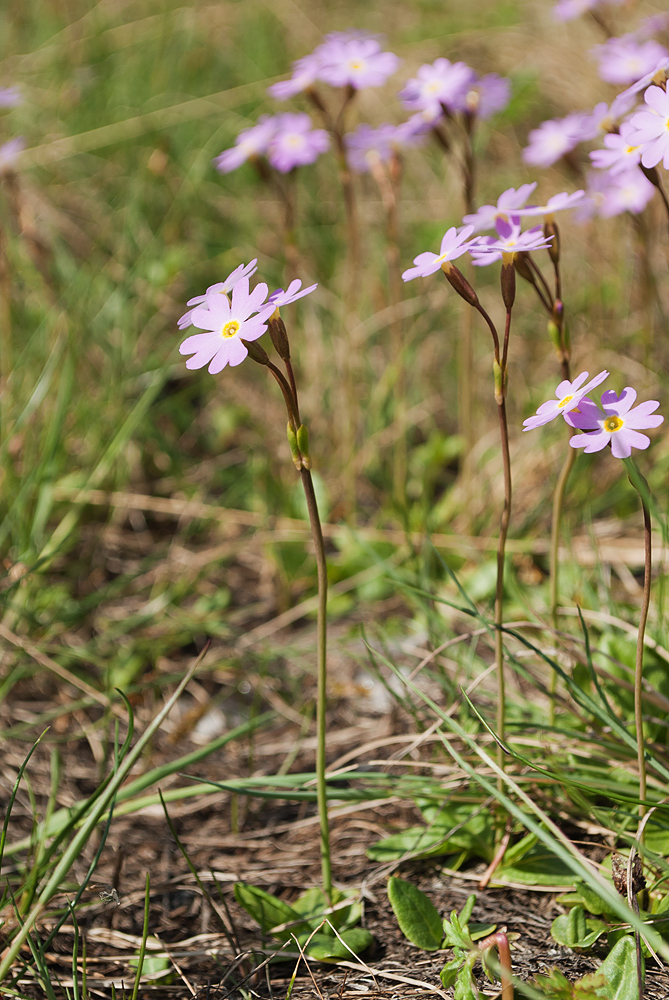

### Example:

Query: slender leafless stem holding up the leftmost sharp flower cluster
xmin=300 ymin=466 xmax=332 ymax=901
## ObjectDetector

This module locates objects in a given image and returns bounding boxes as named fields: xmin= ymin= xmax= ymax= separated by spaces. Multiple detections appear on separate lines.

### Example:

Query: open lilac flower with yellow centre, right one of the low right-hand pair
xmin=569 ymin=386 xmax=664 ymax=458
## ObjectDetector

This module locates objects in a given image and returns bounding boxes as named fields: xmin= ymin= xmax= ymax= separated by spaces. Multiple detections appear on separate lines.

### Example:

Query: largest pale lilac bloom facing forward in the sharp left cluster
xmin=179 ymin=278 xmax=276 ymax=375
